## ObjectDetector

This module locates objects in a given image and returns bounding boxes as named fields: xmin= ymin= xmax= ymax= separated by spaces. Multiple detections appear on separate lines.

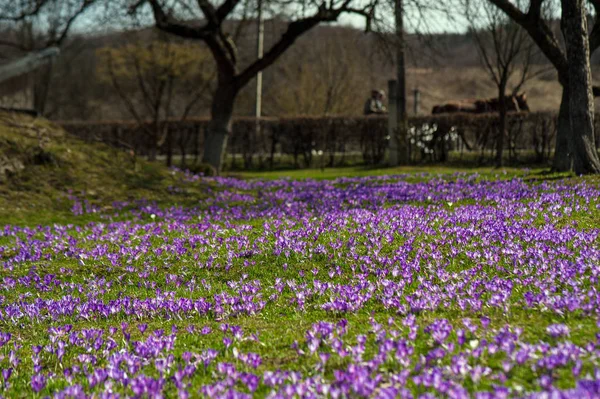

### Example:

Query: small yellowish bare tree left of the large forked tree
xmin=97 ymin=34 xmax=214 ymax=166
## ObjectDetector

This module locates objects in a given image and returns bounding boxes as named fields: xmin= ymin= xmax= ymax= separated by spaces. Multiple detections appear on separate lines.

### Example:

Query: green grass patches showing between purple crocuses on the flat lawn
xmin=0 ymin=217 xmax=595 ymax=397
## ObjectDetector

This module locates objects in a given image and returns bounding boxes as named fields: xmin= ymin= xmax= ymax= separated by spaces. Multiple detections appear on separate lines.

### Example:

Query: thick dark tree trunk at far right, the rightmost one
xmin=561 ymin=0 xmax=600 ymax=175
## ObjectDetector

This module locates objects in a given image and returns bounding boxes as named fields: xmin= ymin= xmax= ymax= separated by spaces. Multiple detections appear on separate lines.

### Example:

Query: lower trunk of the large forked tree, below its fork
xmin=202 ymin=82 xmax=237 ymax=173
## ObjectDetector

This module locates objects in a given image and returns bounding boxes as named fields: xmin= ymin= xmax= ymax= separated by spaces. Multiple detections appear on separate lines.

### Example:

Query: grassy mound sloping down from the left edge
xmin=0 ymin=113 xmax=217 ymax=224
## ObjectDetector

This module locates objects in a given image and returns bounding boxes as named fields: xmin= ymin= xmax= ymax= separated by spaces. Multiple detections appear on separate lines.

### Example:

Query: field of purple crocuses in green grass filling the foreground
xmin=0 ymin=172 xmax=600 ymax=398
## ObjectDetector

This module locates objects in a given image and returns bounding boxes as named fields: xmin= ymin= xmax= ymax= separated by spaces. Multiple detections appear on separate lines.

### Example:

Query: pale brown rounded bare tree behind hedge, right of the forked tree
xmin=265 ymin=28 xmax=371 ymax=116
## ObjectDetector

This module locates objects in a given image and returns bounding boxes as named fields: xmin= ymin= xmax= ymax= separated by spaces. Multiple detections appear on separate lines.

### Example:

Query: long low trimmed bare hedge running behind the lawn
xmin=56 ymin=112 xmax=598 ymax=168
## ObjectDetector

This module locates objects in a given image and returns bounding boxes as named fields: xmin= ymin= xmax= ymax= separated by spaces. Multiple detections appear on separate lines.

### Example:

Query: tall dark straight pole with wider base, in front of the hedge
xmin=390 ymin=0 xmax=408 ymax=166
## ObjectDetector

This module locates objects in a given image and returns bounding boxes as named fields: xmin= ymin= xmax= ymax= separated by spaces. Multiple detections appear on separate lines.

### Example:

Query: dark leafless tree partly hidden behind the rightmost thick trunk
xmin=487 ymin=0 xmax=600 ymax=174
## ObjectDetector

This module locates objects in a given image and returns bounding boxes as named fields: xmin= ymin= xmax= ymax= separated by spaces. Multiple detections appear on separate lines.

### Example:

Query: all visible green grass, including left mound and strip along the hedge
xmin=0 ymin=112 xmax=600 ymax=397
